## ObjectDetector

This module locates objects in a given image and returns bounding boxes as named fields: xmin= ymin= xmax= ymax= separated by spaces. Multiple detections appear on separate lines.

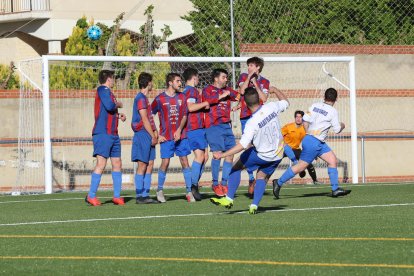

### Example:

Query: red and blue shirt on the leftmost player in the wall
xmin=92 ymin=85 xmax=118 ymax=135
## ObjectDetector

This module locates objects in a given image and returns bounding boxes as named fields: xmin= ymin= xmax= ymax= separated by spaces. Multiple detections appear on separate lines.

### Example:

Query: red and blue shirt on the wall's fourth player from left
xmin=183 ymin=85 xmax=204 ymax=131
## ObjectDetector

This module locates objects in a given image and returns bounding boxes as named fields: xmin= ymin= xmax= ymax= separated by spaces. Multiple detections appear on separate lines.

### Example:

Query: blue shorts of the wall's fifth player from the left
xmin=205 ymin=123 xmax=236 ymax=152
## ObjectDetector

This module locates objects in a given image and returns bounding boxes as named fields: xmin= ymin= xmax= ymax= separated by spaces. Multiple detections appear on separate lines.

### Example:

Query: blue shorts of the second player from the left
xmin=131 ymin=129 xmax=155 ymax=164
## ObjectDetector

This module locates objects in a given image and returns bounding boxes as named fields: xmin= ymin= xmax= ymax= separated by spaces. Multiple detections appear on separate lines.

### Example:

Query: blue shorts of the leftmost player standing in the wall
xmin=92 ymin=133 xmax=121 ymax=158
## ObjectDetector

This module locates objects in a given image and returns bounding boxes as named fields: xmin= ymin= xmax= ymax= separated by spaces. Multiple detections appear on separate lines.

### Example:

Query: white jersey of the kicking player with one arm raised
xmin=240 ymin=100 xmax=289 ymax=161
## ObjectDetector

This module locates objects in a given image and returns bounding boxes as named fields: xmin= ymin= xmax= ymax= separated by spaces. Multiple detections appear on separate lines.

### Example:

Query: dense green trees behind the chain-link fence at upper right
xmin=175 ymin=0 xmax=414 ymax=56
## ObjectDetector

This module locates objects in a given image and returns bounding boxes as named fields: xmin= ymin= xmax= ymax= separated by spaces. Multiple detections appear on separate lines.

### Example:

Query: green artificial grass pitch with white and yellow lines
xmin=0 ymin=183 xmax=414 ymax=275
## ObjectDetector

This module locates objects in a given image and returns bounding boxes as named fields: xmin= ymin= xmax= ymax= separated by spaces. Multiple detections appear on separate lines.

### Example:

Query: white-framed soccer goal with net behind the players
xmin=13 ymin=56 xmax=357 ymax=193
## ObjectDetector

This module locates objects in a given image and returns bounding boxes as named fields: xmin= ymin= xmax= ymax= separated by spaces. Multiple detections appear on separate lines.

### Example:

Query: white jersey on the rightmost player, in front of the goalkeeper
xmin=303 ymin=103 xmax=341 ymax=142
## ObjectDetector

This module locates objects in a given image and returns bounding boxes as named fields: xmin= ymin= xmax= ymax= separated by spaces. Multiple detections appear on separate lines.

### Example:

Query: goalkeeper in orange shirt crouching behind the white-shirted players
xmin=282 ymin=110 xmax=320 ymax=185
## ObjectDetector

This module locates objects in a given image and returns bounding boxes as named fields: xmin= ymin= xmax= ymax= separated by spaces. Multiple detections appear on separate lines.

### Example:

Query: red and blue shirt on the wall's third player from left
xmin=151 ymin=92 xmax=188 ymax=141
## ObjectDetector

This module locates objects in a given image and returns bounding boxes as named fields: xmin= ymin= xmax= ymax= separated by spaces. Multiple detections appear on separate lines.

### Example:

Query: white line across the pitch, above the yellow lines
xmin=0 ymin=203 xmax=414 ymax=226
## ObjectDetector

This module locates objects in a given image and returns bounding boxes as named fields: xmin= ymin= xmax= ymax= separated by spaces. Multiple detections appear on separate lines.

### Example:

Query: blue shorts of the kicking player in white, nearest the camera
xmin=240 ymin=147 xmax=282 ymax=176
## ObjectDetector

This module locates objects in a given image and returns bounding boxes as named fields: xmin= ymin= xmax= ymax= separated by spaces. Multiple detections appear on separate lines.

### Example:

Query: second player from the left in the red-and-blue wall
xmin=131 ymin=72 xmax=158 ymax=204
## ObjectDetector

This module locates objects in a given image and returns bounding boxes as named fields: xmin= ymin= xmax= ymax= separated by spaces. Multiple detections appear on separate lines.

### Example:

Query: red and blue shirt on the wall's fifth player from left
xmin=203 ymin=85 xmax=239 ymax=128
